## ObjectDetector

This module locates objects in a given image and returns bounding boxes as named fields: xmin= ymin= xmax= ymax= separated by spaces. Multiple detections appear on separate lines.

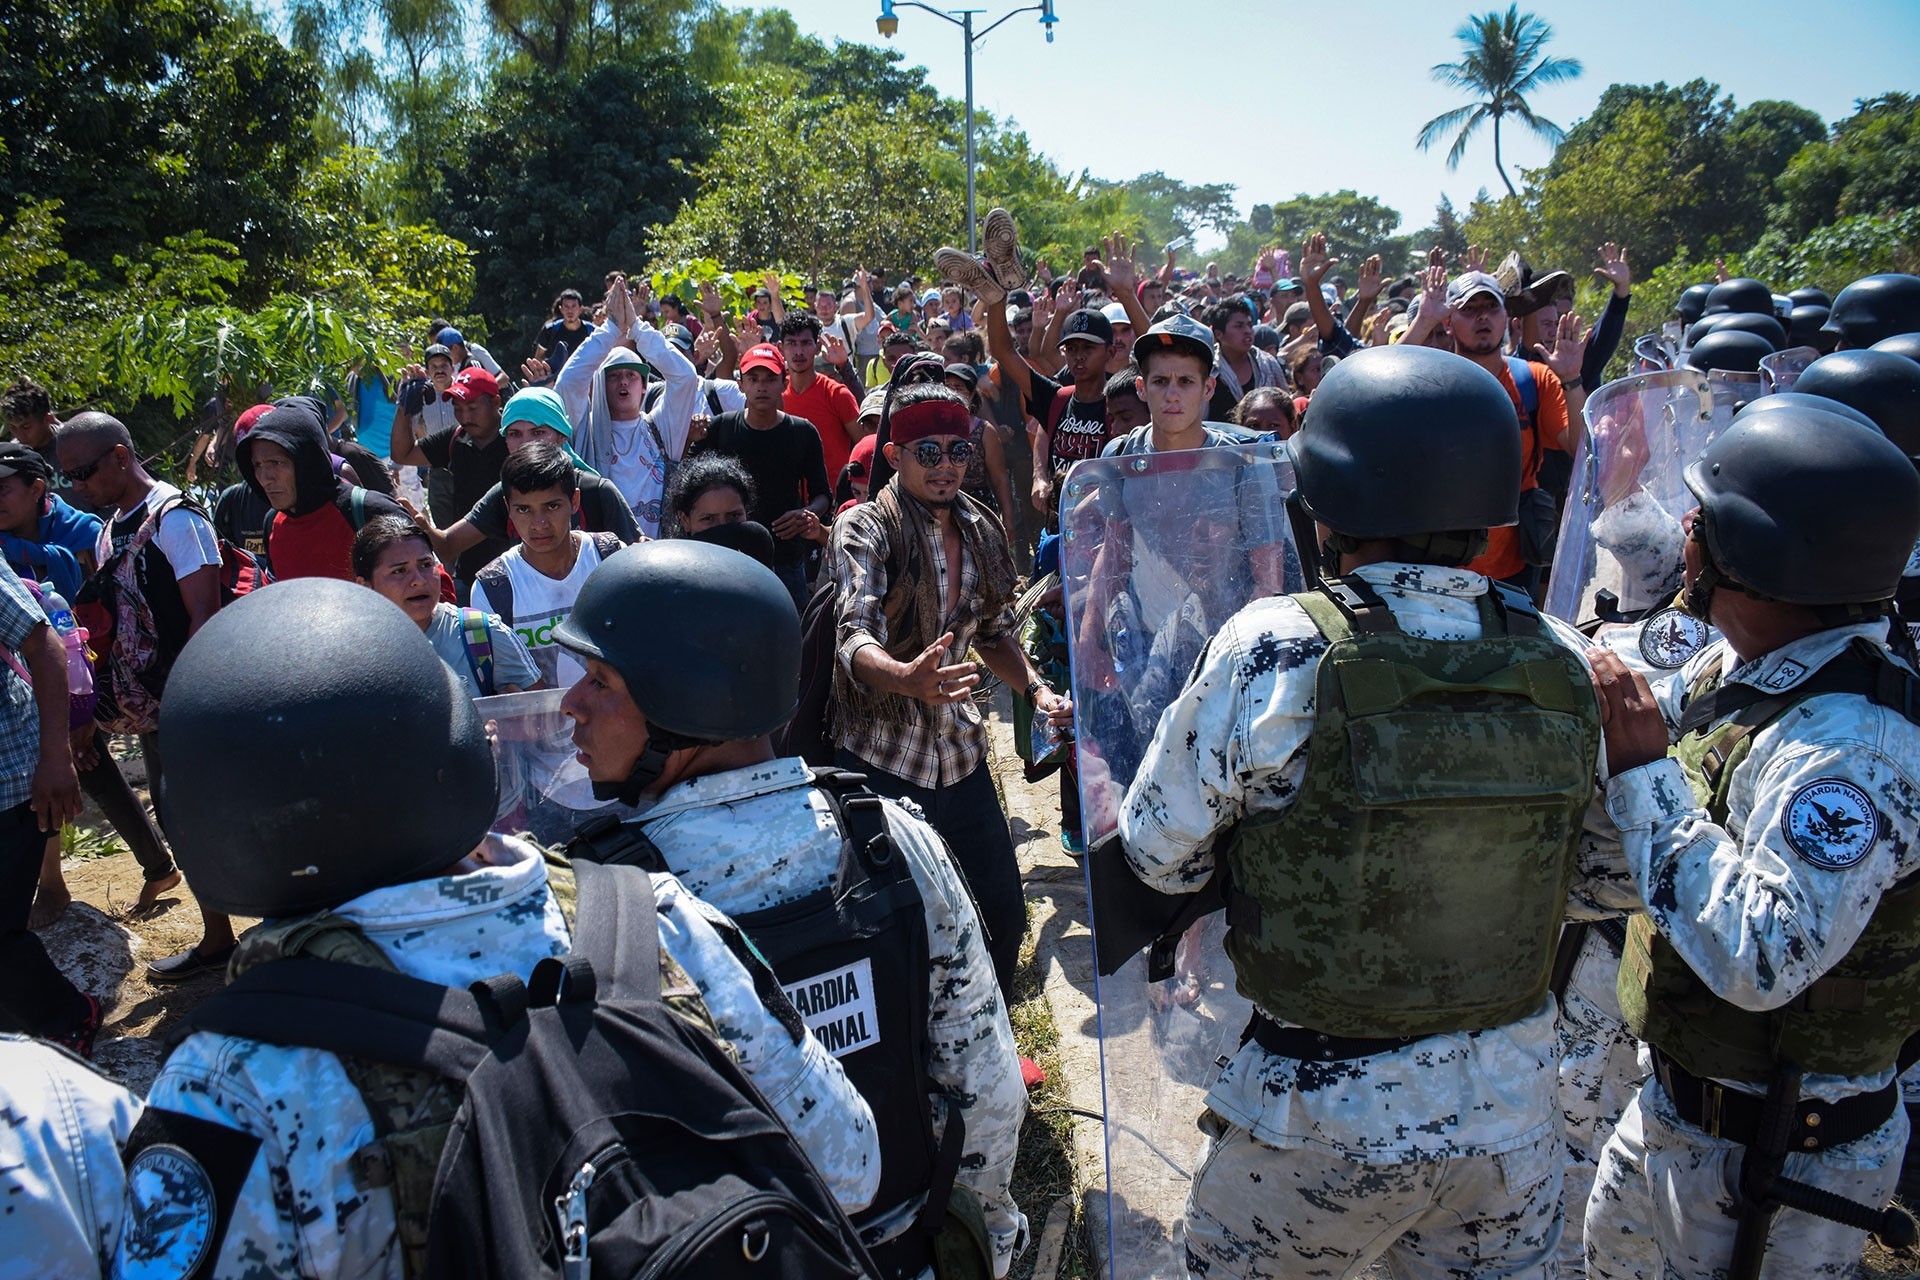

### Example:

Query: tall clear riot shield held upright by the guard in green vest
xmin=1060 ymin=443 xmax=1304 ymax=1278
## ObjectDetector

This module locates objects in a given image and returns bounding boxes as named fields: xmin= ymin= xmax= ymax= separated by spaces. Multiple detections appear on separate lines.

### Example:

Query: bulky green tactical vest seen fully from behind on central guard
xmin=1227 ymin=578 xmax=1599 ymax=1036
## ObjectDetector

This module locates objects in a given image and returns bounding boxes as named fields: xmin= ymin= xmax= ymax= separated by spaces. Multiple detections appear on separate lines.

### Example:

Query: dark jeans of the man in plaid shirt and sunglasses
xmin=835 ymin=747 xmax=1027 ymax=1007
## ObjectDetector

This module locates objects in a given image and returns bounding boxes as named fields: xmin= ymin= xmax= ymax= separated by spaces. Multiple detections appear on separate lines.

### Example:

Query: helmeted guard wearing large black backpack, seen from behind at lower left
xmin=115 ymin=580 xmax=879 ymax=1280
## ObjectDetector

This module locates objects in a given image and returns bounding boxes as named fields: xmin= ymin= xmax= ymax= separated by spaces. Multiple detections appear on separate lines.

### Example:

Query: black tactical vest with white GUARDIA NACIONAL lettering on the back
xmin=574 ymin=770 xmax=972 ymax=1276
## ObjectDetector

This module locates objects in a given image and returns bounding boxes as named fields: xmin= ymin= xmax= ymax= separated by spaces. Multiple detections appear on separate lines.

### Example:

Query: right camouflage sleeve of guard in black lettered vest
xmin=887 ymin=802 xmax=1027 ymax=1276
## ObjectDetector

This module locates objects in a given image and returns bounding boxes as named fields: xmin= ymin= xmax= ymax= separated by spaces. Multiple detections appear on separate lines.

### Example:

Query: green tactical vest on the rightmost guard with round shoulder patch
xmin=1619 ymin=641 xmax=1920 ymax=1082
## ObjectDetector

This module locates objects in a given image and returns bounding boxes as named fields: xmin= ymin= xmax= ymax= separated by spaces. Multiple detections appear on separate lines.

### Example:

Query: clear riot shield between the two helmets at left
xmin=474 ymin=689 xmax=601 ymax=844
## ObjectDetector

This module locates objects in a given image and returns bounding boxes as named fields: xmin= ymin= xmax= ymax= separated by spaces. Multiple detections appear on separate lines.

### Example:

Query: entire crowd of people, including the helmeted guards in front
xmin=0 ymin=197 xmax=1920 ymax=1278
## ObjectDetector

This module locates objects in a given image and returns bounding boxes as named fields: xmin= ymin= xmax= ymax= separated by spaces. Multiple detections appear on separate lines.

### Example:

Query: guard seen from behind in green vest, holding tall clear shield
xmin=1119 ymin=347 xmax=1605 ymax=1276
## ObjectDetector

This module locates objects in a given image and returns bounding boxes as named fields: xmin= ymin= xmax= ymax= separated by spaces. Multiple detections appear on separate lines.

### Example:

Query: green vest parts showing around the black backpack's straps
xmin=227 ymin=850 xmax=718 ymax=1276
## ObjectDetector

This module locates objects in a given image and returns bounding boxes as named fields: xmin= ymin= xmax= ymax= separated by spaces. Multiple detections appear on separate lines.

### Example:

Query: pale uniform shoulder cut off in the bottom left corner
xmin=0 ymin=1034 xmax=140 ymax=1280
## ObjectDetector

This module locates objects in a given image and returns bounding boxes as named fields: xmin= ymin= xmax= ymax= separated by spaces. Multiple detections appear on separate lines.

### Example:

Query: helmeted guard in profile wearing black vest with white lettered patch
xmin=557 ymin=541 xmax=1027 ymax=1276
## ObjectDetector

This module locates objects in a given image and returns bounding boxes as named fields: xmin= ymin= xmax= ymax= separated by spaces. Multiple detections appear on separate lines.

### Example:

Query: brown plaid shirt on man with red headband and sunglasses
xmin=831 ymin=489 xmax=1014 ymax=789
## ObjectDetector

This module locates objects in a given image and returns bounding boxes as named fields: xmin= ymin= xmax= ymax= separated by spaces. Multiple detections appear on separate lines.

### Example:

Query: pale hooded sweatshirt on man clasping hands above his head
xmin=555 ymin=320 xmax=701 ymax=537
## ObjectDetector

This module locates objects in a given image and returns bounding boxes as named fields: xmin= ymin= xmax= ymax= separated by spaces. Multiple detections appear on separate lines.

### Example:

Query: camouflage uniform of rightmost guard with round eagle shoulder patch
xmin=1586 ymin=622 xmax=1920 ymax=1278
